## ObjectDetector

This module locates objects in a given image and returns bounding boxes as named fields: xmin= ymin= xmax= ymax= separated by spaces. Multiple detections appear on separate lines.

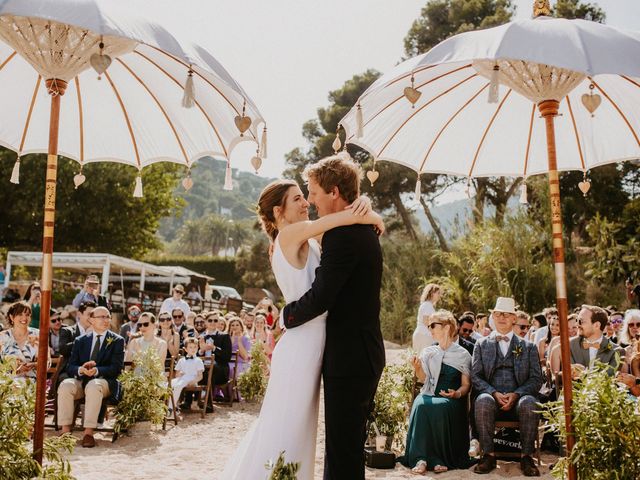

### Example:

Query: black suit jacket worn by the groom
xmin=283 ymin=225 xmax=385 ymax=377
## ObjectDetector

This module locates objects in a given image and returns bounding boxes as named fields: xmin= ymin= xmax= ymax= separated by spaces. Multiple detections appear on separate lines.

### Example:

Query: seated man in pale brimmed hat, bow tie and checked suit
xmin=471 ymin=297 xmax=542 ymax=477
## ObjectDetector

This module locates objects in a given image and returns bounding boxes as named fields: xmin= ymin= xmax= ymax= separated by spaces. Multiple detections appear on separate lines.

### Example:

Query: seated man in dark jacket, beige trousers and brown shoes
xmin=58 ymin=307 xmax=124 ymax=448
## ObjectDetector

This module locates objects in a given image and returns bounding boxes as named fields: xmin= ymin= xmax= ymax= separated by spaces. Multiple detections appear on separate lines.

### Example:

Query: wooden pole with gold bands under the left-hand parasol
xmin=33 ymin=79 xmax=67 ymax=465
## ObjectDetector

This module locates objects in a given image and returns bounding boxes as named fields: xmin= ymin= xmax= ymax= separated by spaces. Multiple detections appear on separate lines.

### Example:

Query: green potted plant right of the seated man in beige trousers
xmin=114 ymin=348 xmax=171 ymax=435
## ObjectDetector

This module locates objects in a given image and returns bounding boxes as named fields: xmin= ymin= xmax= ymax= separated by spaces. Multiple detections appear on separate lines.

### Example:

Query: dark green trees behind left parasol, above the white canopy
xmin=0 ymin=150 xmax=182 ymax=257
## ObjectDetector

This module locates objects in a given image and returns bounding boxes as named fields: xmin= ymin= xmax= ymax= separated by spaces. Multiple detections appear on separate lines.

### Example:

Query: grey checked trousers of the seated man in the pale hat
xmin=475 ymin=393 xmax=539 ymax=455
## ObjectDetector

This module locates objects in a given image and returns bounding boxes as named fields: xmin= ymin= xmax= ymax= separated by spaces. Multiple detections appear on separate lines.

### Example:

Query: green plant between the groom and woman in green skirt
xmin=369 ymin=362 xmax=413 ymax=449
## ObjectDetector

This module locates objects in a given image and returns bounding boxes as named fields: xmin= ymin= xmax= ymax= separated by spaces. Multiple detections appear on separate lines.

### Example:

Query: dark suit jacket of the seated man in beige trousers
xmin=67 ymin=330 xmax=124 ymax=403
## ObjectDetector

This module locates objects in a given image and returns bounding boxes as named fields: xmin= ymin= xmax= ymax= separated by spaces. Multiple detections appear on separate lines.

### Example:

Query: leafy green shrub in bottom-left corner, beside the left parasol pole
xmin=0 ymin=359 xmax=76 ymax=480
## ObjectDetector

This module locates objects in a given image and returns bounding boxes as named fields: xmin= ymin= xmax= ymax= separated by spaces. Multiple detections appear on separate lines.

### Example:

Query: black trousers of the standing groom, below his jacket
xmin=323 ymin=376 xmax=380 ymax=480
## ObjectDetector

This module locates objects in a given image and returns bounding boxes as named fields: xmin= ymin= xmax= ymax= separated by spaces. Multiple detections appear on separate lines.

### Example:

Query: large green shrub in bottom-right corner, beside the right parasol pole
xmin=543 ymin=363 xmax=640 ymax=480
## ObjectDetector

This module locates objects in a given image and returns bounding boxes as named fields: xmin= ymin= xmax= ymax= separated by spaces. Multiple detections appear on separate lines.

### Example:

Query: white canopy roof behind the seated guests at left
xmin=4 ymin=252 xmax=213 ymax=294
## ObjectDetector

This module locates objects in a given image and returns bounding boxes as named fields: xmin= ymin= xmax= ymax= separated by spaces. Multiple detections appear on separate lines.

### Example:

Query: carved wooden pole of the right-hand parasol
xmin=538 ymin=100 xmax=577 ymax=480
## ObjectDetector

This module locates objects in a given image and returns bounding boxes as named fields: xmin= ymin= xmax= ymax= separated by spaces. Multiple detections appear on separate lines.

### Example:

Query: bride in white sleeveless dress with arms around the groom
xmin=220 ymin=180 xmax=384 ymax=480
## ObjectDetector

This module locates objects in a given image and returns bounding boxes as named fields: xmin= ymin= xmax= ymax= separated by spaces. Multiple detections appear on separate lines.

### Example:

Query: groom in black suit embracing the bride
xmin=282 ymin=156 xmax=385 ymax=480
